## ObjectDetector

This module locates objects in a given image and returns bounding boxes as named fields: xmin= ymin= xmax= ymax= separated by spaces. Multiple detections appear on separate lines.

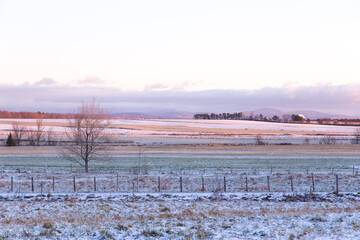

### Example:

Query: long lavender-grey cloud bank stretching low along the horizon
xmin=0 ymin=81 xmax=360 ymax=115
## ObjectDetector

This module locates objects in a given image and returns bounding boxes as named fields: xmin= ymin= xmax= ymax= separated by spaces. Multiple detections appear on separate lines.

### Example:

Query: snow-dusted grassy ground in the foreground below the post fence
xmin=0 ymin=193 xmax=360 ymax=239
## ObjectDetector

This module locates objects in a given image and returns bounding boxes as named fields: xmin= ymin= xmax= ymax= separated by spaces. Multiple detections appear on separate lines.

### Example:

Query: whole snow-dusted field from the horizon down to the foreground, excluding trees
xmin=0 ymin=119 xmax=360 ymax=239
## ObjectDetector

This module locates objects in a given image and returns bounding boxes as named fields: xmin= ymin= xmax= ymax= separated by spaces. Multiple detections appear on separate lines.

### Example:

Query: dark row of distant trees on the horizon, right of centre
xmin=194 ymin=112 xmax=306 ymax=122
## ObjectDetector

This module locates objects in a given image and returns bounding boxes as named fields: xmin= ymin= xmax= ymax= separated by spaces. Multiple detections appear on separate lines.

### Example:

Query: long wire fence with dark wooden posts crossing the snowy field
xmin=0 ymin=173 xmax=360 ymax=194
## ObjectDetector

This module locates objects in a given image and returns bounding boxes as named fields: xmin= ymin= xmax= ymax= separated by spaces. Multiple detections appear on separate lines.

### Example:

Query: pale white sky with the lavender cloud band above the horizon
xmin=0 ymin=0 xmax=360 ymax=115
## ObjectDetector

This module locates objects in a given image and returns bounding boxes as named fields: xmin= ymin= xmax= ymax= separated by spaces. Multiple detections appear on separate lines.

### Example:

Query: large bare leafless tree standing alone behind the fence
xmin=62 ymin=99 xmax=110 ymax=172
